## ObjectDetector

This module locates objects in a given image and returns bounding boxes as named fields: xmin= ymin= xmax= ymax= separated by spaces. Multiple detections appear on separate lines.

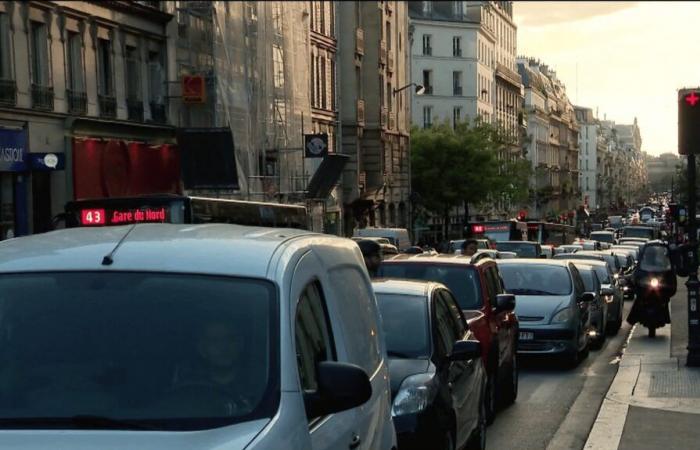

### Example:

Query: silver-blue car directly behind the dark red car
xmin=498 ymin=259 xmax=595 ymax=366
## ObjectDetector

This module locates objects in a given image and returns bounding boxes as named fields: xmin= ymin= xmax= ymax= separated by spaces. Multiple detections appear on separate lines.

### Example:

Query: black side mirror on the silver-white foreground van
xmin=304 ymin=361 xmax=372 ymax=418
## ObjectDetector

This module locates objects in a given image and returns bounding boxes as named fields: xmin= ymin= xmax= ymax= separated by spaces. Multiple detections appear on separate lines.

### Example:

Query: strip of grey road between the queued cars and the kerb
xmin=487 ymin=301 xmax=632 ymax=450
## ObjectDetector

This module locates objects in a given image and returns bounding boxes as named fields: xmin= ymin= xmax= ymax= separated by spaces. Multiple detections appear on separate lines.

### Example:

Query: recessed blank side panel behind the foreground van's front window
xmin=329 ymin=268 xmax=382 ymax=374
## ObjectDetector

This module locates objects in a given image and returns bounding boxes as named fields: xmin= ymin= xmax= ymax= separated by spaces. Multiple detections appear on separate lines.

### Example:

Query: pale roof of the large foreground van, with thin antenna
xmin=0 ymin=224 xmax=322 ymax=277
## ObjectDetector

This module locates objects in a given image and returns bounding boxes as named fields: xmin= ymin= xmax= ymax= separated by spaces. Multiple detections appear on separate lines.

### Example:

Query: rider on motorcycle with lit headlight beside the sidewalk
xmin=627 ymin=241 xmax=676 ymax=337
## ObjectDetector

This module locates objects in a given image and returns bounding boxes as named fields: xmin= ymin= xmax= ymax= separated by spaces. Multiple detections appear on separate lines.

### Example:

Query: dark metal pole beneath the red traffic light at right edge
xmin=685 ymin=153 xmax=700 ymax=367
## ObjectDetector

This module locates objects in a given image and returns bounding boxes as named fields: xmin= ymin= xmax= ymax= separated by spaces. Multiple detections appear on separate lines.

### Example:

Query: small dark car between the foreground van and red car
xmin=372 ymin=279 xmax=487 ymax=450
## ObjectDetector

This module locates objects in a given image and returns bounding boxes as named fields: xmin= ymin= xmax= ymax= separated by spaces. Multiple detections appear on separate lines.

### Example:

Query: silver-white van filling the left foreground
xmin=0 ymin=224 xmax=396 ymax=450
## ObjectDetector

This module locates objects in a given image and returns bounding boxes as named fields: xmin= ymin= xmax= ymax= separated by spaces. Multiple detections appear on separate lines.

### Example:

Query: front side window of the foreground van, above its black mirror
xmin=294 ymin=282 xmax=334 ymax=391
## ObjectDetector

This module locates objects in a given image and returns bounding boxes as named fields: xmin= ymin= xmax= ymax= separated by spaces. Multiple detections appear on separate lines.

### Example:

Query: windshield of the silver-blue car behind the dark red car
xmin=499 ymin=264 xmax=571 ymax=295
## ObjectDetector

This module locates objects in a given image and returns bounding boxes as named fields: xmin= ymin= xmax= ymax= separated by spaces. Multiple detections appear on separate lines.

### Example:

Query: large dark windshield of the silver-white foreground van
xmin=0 ymin=271 xmax=279 ymax=430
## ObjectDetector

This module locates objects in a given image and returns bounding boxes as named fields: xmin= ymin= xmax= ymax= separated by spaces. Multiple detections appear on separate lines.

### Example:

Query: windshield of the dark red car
xmin=379 ymin=263 xmax=483 ymax=309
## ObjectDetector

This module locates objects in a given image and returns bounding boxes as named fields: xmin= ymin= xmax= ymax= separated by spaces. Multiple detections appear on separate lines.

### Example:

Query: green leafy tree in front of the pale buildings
xmin=411 ymin=121 xmax=527 ymax=237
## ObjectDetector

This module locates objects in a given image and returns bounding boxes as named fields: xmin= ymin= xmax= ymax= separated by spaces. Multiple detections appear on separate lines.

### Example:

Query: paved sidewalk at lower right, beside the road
xmin=585 ymin=278 xmax=700 ymax=450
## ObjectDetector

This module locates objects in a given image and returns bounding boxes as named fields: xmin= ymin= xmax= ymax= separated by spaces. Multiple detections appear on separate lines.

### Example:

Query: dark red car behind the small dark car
xmin=378 ymin=255 xmax=518 ymax=423
